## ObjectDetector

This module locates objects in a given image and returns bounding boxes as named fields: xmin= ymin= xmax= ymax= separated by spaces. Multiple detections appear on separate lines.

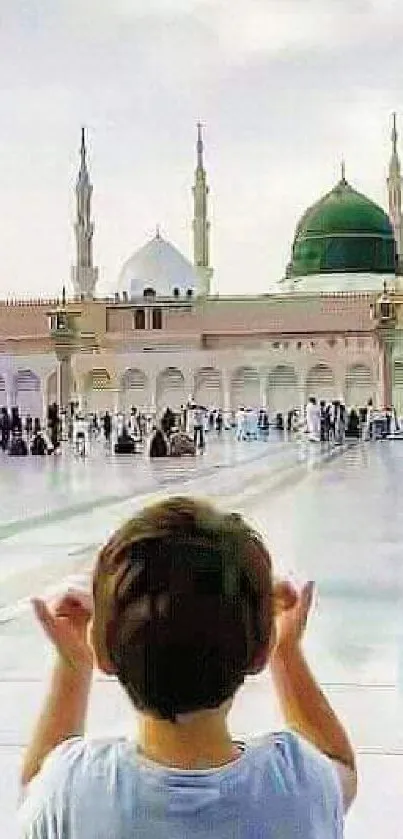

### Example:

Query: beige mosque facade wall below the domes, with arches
xmin=0 ymin=295 xmax=386 ymax=411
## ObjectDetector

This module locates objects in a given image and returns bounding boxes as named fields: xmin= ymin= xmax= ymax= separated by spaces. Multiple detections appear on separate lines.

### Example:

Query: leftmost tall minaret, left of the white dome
xmin=71 ymin=128 xmax=98 ymax=300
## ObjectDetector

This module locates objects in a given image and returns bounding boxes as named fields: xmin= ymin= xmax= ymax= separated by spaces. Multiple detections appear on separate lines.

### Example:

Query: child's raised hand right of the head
xmin=273 ymin=581 xmax=315 ymax=655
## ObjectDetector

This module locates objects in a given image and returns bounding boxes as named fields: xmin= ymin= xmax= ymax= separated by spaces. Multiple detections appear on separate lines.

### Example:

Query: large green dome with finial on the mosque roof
xmin=287 ymin=178 xmax=396 ymax=277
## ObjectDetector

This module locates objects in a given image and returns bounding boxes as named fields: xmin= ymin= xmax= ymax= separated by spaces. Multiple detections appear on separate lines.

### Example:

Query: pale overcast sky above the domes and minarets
xmin=0 ymin=0 xmax=403 ymax=297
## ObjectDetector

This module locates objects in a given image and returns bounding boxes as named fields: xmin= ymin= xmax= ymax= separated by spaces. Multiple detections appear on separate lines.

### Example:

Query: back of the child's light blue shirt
xmin=19 ymin=732 xmax=343 ymax=839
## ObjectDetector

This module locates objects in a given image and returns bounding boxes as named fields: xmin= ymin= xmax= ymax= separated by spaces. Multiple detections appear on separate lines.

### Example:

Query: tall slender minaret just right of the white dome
xmin=193 ymin=123 xmax=213 ymax=296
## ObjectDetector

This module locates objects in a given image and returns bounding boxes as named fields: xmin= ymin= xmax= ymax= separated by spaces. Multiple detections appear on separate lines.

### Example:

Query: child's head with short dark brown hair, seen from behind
xmin=92 ymin=498 xmax=274 ymax=722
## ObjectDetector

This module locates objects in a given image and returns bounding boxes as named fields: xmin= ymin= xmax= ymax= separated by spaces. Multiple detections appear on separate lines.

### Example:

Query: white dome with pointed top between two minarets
xmin=119 ymin=233 xmax=199 ymax=297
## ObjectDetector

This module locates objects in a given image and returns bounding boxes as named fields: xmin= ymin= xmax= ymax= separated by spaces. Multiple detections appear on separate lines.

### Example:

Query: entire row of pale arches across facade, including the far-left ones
xmin=0 ymin=359 xmax=382 ymax=416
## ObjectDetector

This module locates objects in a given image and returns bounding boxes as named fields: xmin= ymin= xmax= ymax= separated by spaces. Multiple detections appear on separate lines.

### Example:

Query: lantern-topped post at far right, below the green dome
xmin=370 ymin=280 xmax=396 ymax=408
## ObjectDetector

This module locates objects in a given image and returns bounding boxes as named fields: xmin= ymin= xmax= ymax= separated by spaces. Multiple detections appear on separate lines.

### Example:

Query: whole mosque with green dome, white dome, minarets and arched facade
xmin=0 ymin=115 xmax=403 ymax=416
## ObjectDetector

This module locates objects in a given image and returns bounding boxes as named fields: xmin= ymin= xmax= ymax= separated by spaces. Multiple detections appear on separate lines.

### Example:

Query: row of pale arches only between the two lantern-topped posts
xmin=68 ymin=362 xmax=377 ymax=414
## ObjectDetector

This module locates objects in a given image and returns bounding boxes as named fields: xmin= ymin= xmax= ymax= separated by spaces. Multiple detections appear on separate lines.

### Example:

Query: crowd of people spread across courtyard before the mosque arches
xmin=0 ymin=396 xmax=400 ymax=458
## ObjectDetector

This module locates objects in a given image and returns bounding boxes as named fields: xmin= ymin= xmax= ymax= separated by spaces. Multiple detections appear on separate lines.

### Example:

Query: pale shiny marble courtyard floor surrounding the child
xmin=0 ymin=436 xmax=403 ymax=839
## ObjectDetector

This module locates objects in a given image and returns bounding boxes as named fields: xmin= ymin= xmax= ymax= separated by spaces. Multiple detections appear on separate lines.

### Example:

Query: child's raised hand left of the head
xmin=32 ymin=589 xmax=93 ymax=670
